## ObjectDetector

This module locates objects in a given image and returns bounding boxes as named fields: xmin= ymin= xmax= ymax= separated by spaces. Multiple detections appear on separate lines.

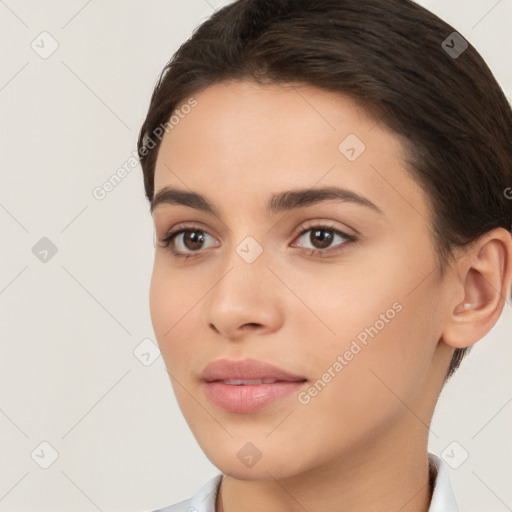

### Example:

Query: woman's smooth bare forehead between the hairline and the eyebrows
xmin=155 ymin=81 xmax=426 ymax=222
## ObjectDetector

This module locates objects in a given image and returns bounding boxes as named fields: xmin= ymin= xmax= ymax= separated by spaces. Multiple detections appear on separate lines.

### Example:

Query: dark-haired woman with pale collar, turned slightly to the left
xmin=139 ymin=0 xmax=512 ymax=512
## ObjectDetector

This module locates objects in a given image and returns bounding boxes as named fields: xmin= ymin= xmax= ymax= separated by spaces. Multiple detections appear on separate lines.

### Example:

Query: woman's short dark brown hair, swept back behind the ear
xmin=138 ymin=0 xmax=512 ymax=376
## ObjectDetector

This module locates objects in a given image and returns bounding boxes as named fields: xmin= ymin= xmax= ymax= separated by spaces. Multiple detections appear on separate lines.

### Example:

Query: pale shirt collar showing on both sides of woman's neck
xmin=153 ymin=453 xmax=459 ymax=512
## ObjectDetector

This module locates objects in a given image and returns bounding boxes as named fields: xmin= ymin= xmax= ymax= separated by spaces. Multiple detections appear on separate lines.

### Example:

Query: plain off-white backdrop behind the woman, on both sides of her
xmin=0 ymin=0 xmax=512 ymax=512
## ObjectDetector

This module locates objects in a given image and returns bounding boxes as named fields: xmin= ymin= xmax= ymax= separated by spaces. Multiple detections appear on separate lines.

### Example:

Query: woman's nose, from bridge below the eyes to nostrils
xmin=204 ymin=244 xmax=283 ymax=341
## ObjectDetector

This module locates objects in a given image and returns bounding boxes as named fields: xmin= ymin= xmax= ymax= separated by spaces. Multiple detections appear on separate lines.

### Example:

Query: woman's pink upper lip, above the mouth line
xmin=200 ymin=359 xmax=307 ymax=382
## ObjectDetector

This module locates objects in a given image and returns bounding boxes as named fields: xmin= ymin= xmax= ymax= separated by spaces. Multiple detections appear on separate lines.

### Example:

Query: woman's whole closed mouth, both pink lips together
xmin=200 ymin=359 xmax=307 ymax=414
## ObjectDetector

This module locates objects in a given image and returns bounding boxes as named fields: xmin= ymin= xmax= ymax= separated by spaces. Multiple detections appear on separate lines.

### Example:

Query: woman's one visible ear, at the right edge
xmin=442 ymin=228 xmax=512 ymax=348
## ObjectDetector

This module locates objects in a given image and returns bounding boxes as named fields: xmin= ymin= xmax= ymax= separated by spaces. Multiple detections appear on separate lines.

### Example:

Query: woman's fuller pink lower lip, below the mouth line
xmin=204 ymin=381 xmax=307 ymax=413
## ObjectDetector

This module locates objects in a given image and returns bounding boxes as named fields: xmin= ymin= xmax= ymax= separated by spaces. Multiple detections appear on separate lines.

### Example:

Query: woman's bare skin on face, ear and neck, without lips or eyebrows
xmin=150 ymin=81 xmax=512 ymax=512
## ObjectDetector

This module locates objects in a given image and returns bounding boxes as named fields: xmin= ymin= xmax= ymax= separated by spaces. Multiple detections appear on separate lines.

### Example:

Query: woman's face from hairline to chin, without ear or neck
xmin=150 ymin=81 xmax=454 ymax=479
